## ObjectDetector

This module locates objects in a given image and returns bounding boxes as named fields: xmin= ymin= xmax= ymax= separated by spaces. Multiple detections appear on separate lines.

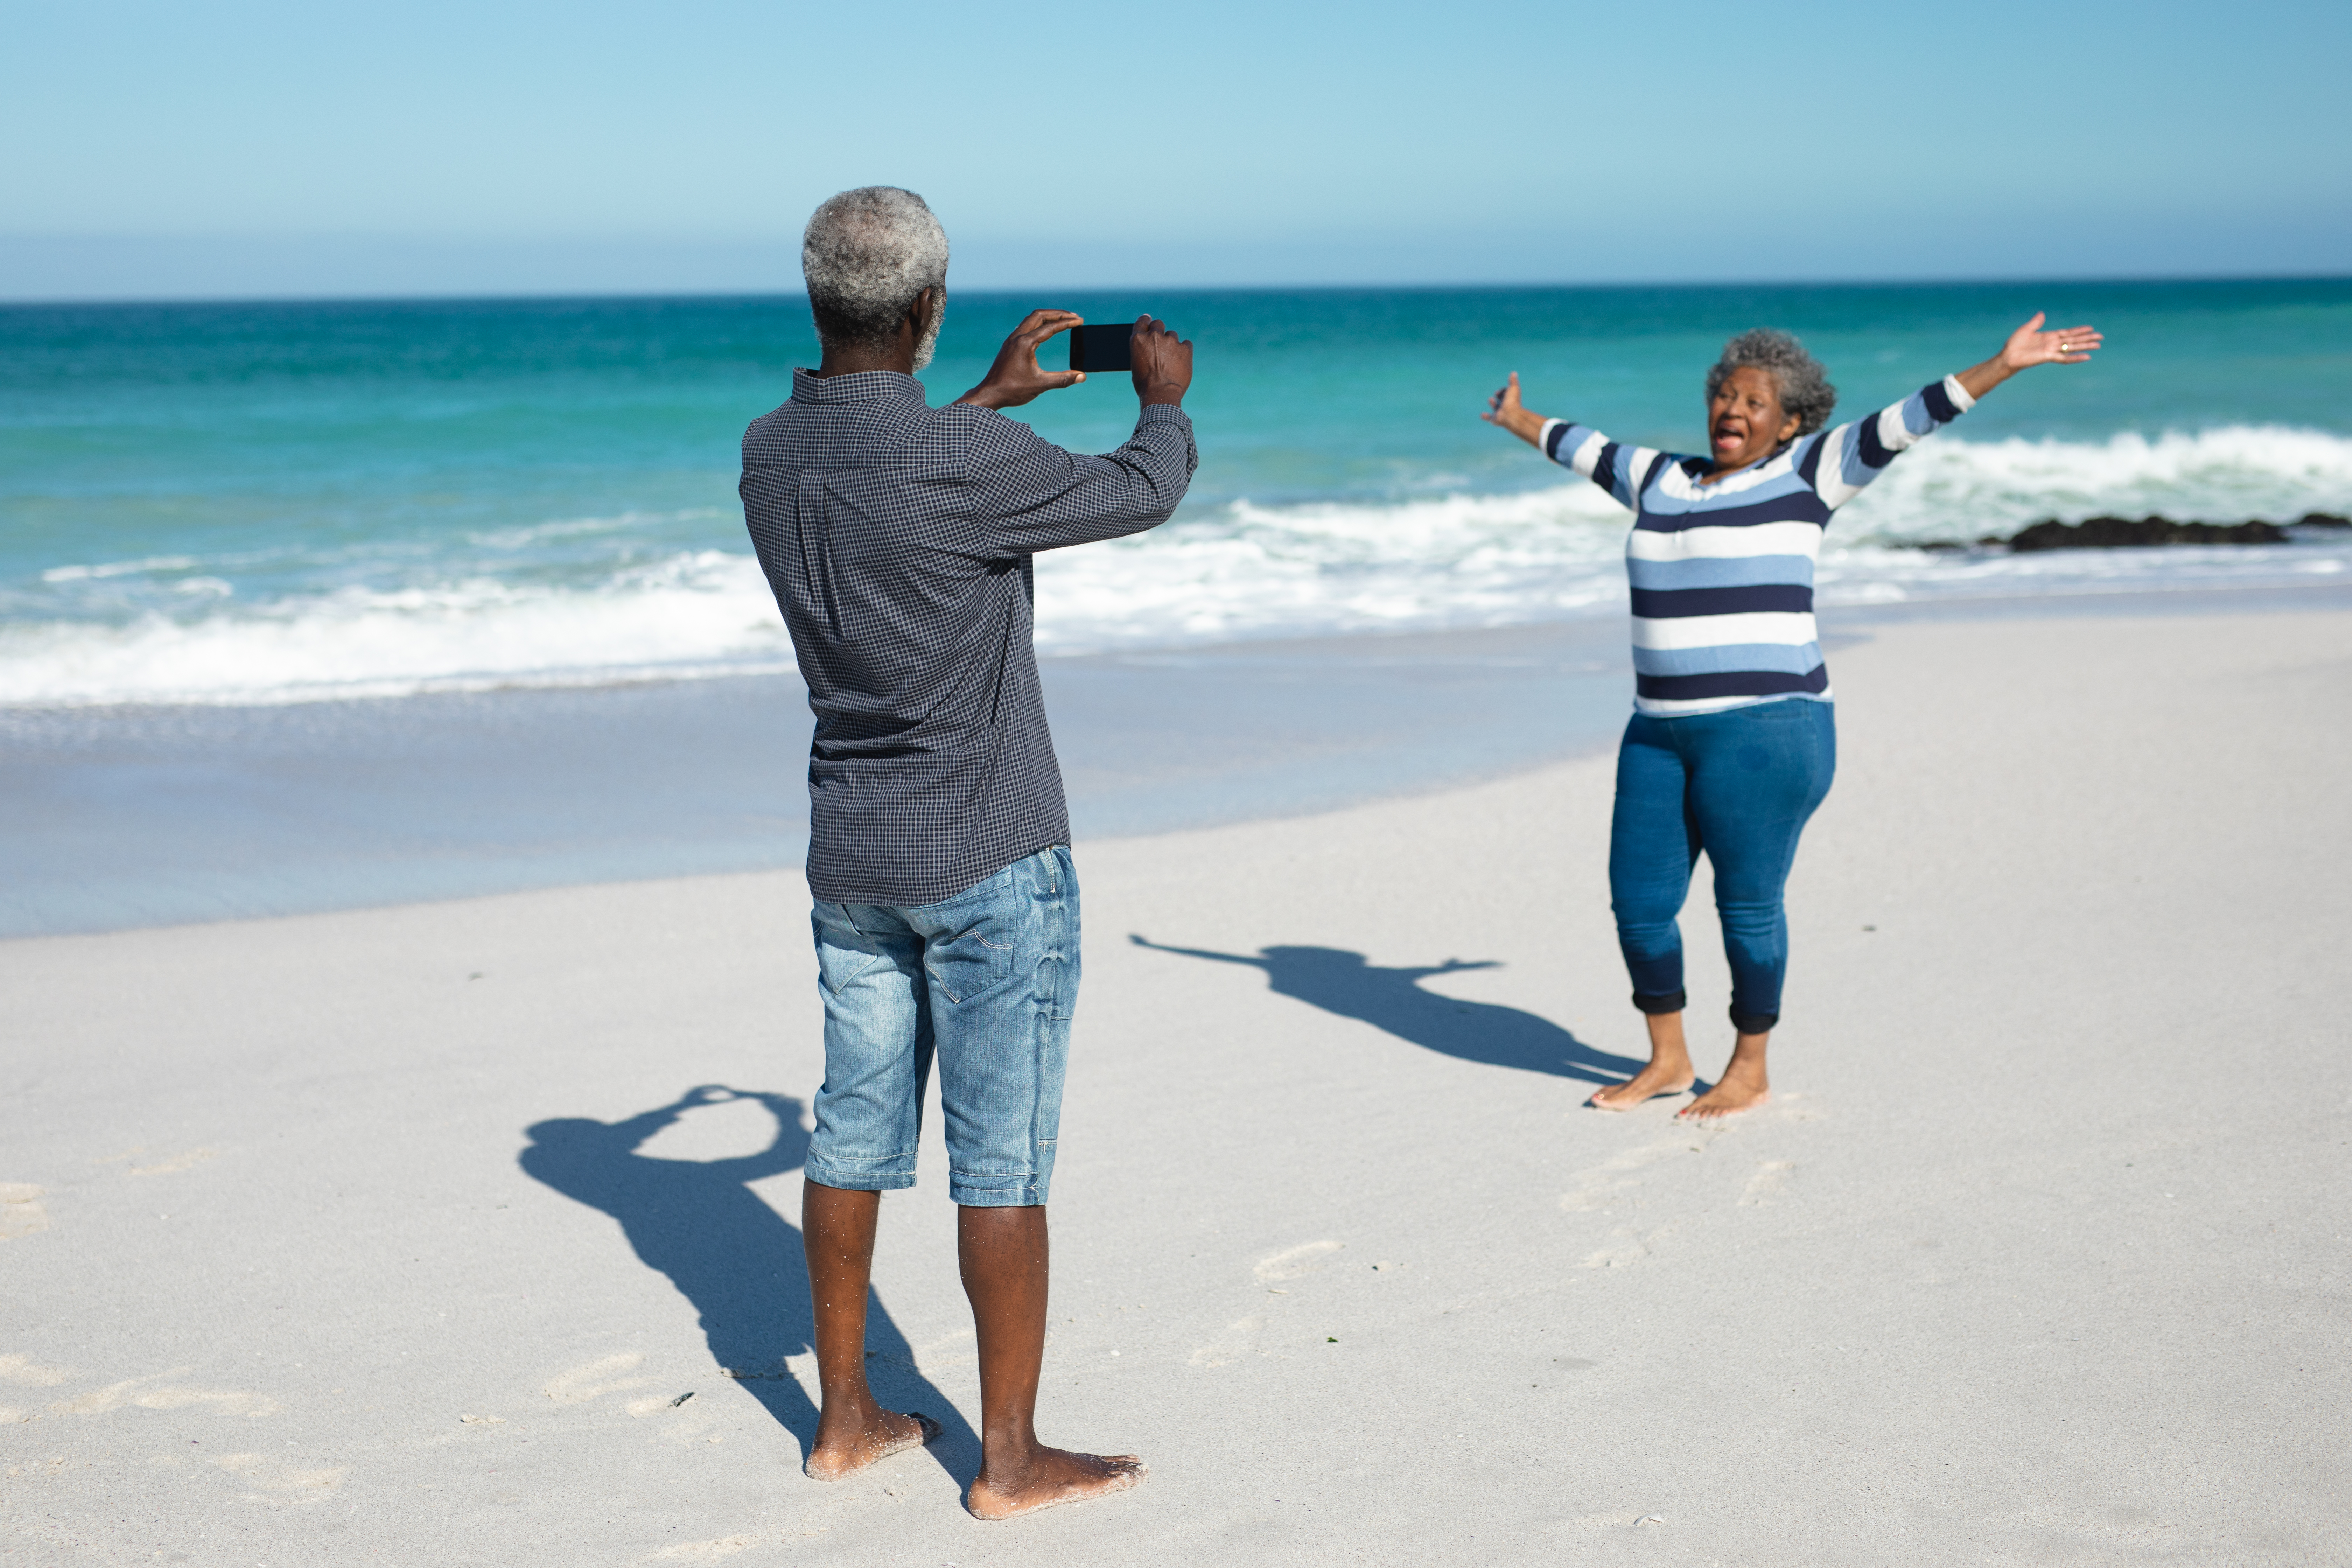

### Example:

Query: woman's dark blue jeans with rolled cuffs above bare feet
xmin=1609 ymin=698 xmax=1837 ymax=1034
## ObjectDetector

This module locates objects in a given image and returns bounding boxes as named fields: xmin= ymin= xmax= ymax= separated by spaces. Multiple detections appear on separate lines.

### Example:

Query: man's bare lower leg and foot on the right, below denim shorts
xmin=955 ymin=1204 xmax=1143 ymax=1519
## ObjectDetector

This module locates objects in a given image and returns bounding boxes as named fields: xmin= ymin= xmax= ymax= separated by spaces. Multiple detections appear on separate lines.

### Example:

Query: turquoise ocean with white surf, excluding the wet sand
xmin=0 ymin=280 xmax=2352 ymax=710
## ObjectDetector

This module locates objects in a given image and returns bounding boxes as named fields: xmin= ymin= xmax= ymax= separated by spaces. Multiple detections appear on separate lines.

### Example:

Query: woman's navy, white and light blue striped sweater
xmin=1536 ymin=376 xmax=1976 ymax=717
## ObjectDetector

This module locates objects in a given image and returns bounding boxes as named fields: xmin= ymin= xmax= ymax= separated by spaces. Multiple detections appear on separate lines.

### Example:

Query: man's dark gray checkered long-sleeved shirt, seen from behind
xmin=741 ymin=369 xmax=1199 ymax=905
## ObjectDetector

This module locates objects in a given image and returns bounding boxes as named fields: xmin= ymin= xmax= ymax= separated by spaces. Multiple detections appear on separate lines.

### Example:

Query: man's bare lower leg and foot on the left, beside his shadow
xmin=800 ymin=1180 xmax=938 ymax=1481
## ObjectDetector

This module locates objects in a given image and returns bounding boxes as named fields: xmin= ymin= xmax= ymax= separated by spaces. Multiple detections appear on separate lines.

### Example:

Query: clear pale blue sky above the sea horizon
xmin=0 ymin=0 xmax=2352 ymax=299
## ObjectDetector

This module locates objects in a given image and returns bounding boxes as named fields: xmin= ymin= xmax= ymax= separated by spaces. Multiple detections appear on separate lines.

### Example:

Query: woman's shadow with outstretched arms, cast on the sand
xmin=1127 ymin=936 xmax=1642 ymax=1084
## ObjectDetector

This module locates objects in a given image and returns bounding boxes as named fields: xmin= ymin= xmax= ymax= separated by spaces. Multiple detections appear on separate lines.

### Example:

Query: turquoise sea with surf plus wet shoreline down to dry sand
xmin=0 ymin=280 xmax=2352 ymax=936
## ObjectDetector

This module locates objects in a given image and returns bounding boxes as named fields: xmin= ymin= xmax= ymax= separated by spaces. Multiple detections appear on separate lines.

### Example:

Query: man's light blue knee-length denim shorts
xmin=807 ymin=844 xmax=1077 ymax=1208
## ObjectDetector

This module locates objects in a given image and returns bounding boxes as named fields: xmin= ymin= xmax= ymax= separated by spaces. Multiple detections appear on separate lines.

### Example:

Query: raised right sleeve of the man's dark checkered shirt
xmin=967 ymin=402 xmax=1199 ymax=557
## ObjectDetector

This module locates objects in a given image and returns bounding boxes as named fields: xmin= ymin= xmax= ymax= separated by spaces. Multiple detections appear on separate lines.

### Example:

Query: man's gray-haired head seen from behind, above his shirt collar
xmin=800 ymin=186 xmax=948 ymax=369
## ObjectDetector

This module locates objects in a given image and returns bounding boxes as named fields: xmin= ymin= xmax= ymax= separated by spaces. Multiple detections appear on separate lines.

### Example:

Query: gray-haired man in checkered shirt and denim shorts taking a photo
xmin=743 ymin=186 xmax=1197 ymax=1519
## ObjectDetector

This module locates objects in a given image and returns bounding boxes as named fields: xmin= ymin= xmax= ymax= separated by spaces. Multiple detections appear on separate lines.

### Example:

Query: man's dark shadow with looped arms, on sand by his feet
xmin=517 ymin=1084 xmax=979 ymax=1462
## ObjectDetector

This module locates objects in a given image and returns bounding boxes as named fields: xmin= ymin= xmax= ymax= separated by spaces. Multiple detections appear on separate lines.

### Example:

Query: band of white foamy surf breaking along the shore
xmin=0 ymin=426 xmax=2352 ymax=705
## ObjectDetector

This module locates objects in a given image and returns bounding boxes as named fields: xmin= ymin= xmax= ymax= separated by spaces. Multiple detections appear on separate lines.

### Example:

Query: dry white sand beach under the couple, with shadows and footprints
xmin=0 ymin=609 xmax=2352 ymax=1568
